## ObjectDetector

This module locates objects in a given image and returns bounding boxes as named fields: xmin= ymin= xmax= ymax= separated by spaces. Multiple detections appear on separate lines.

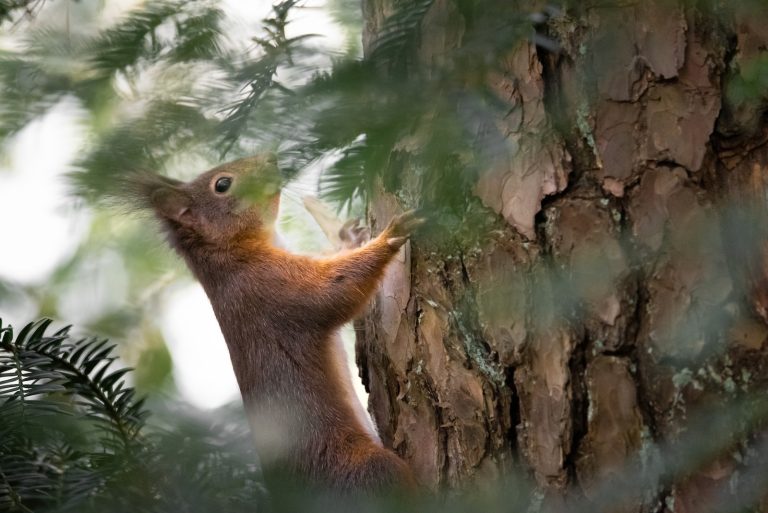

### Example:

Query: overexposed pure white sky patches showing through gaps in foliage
xmin=0 ymin=0 xmax=364 ymax=408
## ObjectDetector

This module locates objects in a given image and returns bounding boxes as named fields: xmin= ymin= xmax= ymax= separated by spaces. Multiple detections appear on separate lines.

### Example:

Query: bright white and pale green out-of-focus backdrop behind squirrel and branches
xmin=0 ymin=0 xmax=352 ymax=409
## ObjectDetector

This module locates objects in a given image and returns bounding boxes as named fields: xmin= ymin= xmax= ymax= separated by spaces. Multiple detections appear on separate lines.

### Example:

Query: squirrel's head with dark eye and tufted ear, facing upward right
xmin=129 ymin=153 xmax=281 ymax=253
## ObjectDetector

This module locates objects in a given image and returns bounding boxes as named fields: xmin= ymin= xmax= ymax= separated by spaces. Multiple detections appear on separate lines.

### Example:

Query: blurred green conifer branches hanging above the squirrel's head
xmin=0 ymin=0 xmax=532 ymax=228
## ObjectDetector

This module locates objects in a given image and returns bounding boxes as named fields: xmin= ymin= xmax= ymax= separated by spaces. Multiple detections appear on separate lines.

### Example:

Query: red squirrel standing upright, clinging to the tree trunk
xmin=129 ymin=154 xmax=423 ymax=493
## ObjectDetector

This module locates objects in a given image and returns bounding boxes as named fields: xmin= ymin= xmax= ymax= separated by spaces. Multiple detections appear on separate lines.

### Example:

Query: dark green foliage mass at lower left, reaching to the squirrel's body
xmin=0 ymin=320 xmax=261 ymax=512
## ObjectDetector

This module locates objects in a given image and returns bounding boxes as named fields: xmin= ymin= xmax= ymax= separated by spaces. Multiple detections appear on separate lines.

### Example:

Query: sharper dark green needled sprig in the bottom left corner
xmin=0 ymin=321 xmax=146 ymax=511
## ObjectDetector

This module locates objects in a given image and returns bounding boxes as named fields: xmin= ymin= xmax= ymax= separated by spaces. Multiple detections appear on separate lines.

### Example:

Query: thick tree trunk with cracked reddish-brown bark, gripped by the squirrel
xmin=358 ymin=0 xmax=768 ymax=513
